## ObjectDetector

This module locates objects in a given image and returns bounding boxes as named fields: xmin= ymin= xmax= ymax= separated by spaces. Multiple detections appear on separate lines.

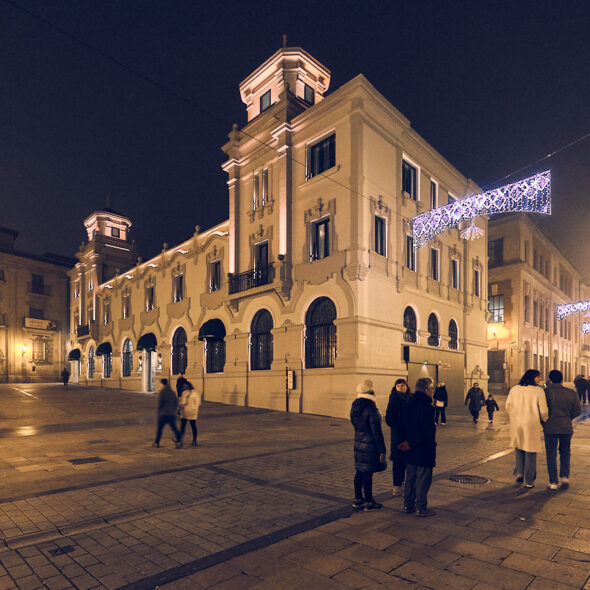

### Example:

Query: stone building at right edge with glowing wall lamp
xmin=488 ymin=214 xmax=590 ymax=391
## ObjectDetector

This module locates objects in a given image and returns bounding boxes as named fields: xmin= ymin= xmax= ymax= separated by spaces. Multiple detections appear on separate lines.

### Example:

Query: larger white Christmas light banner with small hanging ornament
xmin=410 ymin=170 xmax=551 ymax=248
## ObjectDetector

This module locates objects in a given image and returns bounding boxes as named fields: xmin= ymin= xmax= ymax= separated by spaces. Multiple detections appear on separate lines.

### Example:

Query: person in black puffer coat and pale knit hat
xmin=350 ymin=379 xmax=386 ymax=510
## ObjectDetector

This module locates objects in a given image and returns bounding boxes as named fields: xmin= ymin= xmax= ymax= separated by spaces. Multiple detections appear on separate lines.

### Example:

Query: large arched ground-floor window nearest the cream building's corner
xmin=305 ymin=297 xmax=336 ymax=369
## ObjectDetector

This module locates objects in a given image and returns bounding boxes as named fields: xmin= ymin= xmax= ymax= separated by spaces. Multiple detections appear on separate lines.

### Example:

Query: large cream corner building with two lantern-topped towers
xmin=71 ymin=48 xmax=487 ymax=416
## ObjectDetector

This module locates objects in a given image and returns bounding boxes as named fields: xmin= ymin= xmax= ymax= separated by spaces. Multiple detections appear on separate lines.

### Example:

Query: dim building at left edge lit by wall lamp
xmin=0 ymin=227 xmax=74 ymax=382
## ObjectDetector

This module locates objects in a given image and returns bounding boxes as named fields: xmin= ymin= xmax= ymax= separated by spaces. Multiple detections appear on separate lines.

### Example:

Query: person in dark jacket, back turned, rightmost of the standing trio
xmin=398 ymin=377 xmax=436 ymax=516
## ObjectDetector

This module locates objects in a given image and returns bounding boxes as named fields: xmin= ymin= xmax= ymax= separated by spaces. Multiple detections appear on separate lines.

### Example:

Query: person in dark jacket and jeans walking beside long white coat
xmin=543 ymin=370 xmax=582 ymax=490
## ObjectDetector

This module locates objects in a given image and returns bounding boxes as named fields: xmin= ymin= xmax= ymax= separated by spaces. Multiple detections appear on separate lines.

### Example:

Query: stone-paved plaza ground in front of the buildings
xmin=0 ymin=385 xmax=590 ymax=590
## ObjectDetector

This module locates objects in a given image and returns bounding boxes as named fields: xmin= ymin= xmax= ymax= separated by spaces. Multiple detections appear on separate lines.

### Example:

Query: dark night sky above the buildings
xmin=0 ymin=0 xmax=590 ymax=276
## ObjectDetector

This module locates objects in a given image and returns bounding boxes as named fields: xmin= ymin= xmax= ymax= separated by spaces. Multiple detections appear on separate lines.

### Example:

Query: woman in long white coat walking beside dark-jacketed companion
xmin=506 ymin=369 xmax=549 ymax=488
